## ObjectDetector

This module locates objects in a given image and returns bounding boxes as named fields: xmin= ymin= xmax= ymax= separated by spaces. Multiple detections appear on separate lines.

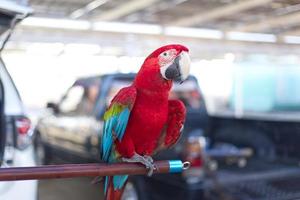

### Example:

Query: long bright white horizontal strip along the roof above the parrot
xmin=11 ymin=27 xmax=300 ymax=58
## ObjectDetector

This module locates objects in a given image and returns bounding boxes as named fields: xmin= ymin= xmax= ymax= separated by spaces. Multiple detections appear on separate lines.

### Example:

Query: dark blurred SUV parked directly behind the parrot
xmin=36 ymin=74 xmax=208 ymax=199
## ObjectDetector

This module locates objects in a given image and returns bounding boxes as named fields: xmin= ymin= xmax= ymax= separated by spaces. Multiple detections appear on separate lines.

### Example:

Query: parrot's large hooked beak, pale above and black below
xmin=161 ymin=51 xmax=191 ymax=82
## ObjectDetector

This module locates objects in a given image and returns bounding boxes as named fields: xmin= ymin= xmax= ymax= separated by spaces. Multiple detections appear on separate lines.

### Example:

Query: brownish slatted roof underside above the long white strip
xmin=29 ymin=0 xmax=300 ymax=35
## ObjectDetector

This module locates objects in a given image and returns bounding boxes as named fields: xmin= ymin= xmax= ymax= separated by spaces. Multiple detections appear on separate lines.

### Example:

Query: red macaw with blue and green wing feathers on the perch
xmin=101 ymin=44 xmax=190 ymax=200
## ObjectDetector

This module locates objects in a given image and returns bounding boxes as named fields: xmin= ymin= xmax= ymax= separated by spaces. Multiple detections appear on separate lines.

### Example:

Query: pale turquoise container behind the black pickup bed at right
xmin=229 ymin=63 xmax=300 ymax=112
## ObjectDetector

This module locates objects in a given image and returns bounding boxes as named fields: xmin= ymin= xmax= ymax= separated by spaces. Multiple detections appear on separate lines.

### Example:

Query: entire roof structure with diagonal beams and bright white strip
xmin=5 ymin=0 xmax=300 ymax=56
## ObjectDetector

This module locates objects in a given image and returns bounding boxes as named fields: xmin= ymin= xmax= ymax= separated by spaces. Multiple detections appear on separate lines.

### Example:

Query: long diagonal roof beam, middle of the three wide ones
xmin=170 ymin=0 xmax=273 ymax=26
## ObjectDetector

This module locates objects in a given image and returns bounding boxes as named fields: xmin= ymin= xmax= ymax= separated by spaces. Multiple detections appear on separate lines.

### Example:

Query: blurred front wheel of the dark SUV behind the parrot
xmin=34 ymin=133 xmax=52 ymax=165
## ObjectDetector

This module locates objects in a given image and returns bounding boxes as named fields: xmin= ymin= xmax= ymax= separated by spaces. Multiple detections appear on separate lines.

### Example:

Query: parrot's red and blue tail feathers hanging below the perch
xmin=104 ymin=176 xmax=127 ymax=200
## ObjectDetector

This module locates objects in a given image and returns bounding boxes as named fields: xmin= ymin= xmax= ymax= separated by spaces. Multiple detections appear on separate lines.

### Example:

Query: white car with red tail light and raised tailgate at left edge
xmin=0 ymin=0 xmax=37 ymax=200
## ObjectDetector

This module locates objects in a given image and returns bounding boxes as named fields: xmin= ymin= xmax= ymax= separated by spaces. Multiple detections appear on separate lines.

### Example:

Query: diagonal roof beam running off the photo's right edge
xmin=234 ymin=12 xmax=300 ymax=32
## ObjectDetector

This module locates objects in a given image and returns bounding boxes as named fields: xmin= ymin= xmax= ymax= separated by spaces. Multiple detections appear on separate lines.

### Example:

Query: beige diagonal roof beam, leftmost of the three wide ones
xmin=92 ymin=0 xmax=159 ymax=21
